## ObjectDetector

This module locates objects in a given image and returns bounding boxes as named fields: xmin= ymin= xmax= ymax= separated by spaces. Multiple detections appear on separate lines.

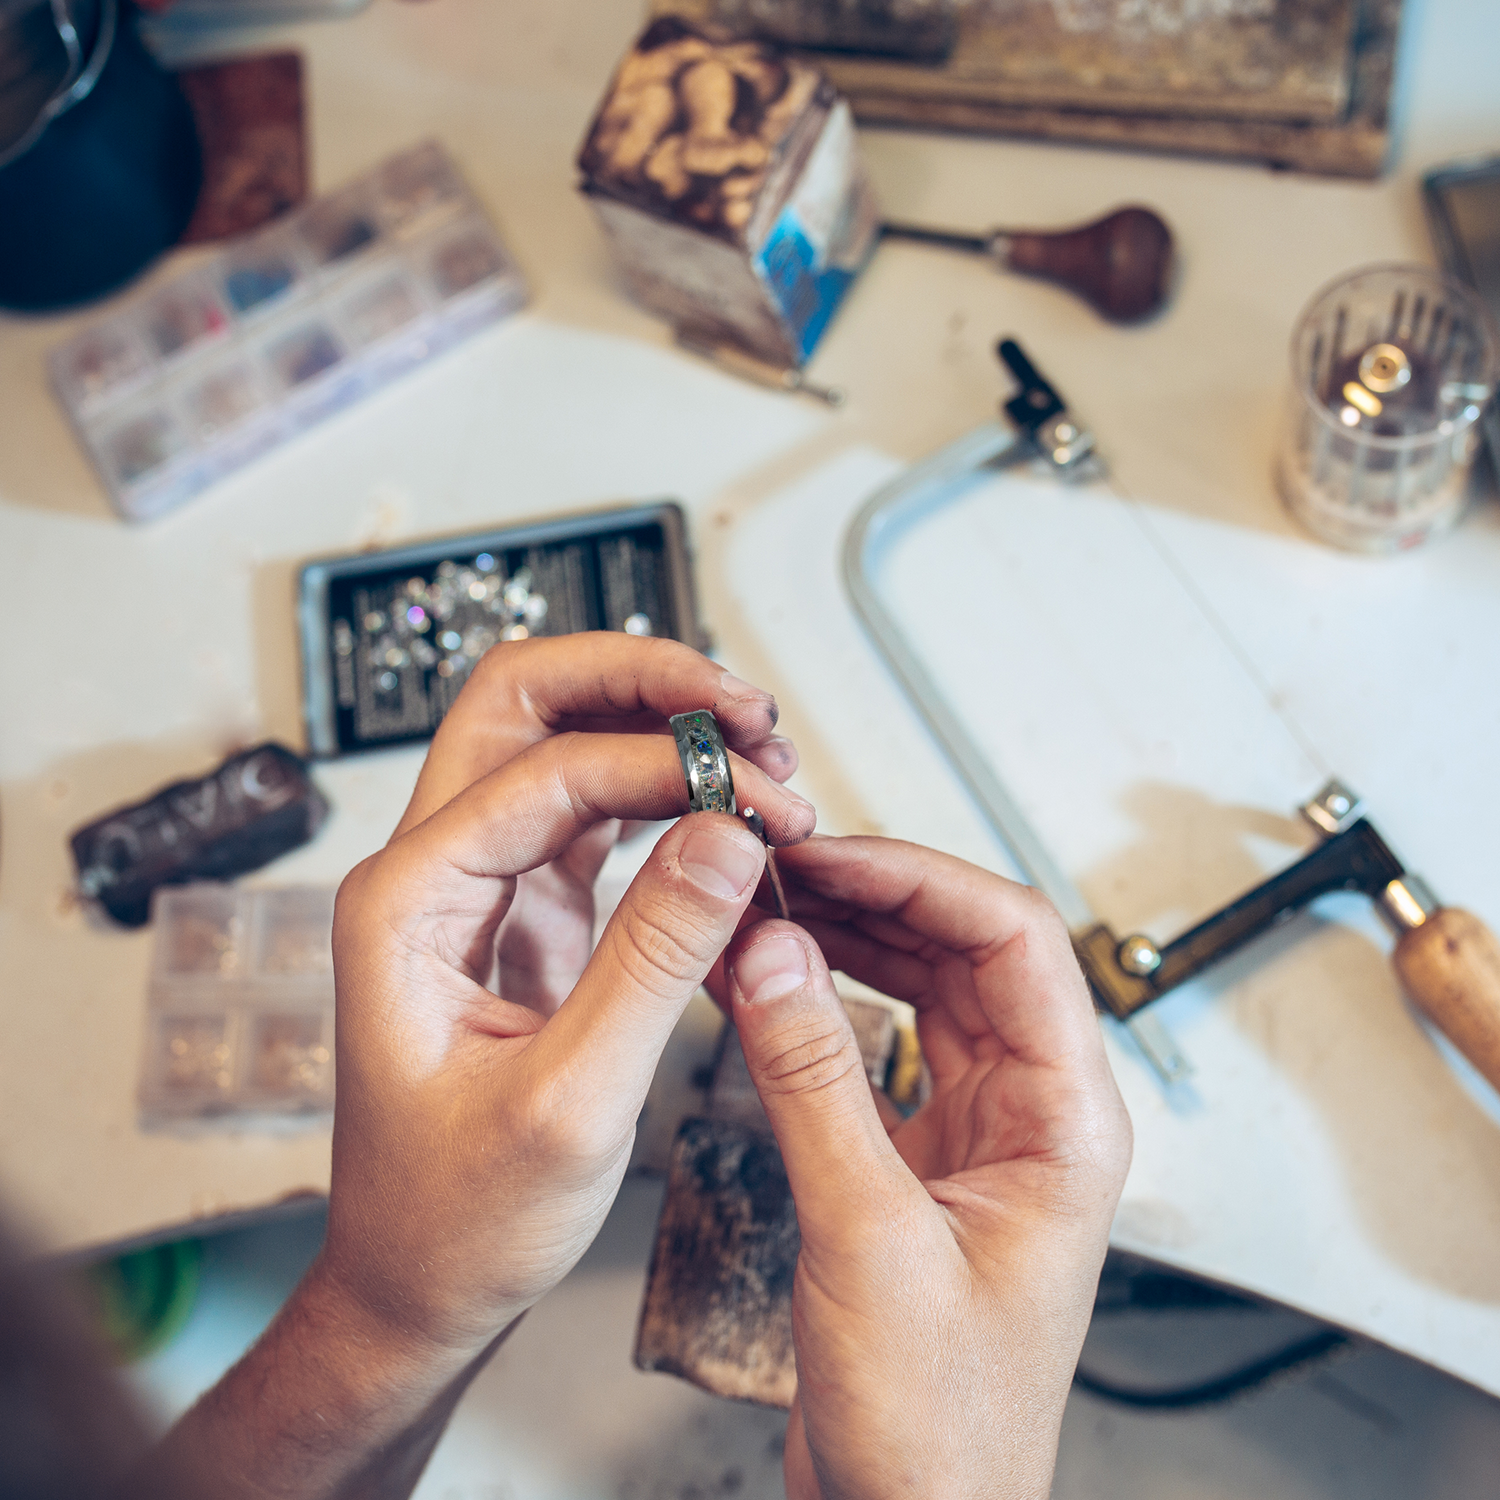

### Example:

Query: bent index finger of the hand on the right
xmin=777 ymin=837 xmax=1103 ymax=1064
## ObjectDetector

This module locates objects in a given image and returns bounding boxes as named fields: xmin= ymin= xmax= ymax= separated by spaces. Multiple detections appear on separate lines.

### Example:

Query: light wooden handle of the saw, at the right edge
xmin=1392 ymin=906 xmax=1500 ymax=1092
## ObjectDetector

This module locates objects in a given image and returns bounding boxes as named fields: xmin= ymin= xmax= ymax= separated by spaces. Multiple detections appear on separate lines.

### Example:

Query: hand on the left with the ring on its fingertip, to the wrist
xmin=320 ymin=635 xmax=815 ymax=1361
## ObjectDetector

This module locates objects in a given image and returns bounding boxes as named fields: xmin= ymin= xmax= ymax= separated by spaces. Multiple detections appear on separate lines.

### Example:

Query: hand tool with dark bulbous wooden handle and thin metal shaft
xmin=881 ymin=206 xmax=1173 ymax=323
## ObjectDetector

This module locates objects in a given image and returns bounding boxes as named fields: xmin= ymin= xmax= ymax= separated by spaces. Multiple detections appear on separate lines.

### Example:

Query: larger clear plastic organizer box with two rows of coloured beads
xmin=50 ymin=141 xmax=527 ymax=521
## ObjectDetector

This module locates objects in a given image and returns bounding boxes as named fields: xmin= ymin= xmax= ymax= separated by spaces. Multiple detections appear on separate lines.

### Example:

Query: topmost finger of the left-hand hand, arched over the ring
xmin=396 ymin=630 xmax=795 ymax=834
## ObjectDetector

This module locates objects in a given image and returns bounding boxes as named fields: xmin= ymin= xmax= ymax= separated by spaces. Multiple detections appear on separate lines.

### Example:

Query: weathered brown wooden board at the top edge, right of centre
xmin=654 ymin=0 xmax=1403 ymax=178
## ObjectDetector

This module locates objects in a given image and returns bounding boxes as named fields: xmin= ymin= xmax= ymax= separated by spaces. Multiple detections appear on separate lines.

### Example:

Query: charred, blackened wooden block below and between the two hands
xmin=636 ymin=1121 xmax=801 ymax=1407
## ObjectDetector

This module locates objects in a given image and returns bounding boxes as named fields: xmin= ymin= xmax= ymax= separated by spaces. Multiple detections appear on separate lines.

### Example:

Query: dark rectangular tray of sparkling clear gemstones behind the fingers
xmin=299 ymin=501 xmax=707 ymax=756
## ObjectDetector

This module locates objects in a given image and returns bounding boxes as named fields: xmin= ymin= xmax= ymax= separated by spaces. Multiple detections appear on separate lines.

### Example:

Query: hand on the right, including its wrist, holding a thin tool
xmin=726 ymin=839 xmax=1131 ymax=1500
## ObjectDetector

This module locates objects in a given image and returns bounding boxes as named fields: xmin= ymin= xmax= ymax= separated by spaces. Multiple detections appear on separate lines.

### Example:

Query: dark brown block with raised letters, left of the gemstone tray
xmin=71 ymin=741 xmax=329 ymax=927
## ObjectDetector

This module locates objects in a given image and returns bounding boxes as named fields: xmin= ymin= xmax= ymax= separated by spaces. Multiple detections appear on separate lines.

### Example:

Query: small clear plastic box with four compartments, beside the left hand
xmin=140 ymin=884 xmax=335 ymax=1125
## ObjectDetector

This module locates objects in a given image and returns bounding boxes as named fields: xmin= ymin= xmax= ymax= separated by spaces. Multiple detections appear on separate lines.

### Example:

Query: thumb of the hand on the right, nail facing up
xmin=726 ymin=921 xmax=915 ymax=1245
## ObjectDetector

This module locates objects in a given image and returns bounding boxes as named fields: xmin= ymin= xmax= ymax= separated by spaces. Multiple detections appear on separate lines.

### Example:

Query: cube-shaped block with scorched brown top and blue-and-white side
xmin=578 ymin=17 xmax=879 ymax=368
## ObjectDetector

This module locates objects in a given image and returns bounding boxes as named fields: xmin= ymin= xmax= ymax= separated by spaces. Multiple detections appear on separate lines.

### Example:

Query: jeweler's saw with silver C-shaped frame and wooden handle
xmin=843 ymin=339 xmax=1500 ymax=1091
